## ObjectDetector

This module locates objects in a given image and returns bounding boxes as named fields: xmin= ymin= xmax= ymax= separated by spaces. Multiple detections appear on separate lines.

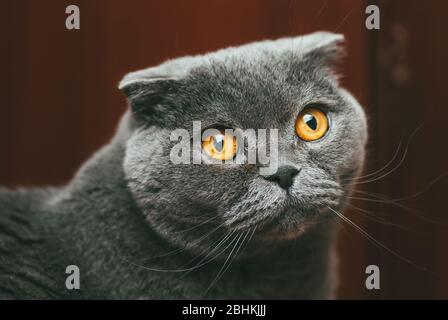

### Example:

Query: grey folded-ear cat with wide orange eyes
xmin=0 ymin=31 xmax=367 ymax=299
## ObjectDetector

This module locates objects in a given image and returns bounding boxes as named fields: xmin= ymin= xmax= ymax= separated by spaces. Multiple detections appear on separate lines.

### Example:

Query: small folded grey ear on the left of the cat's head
xmin=119 ymin=69 xmax=179 ymax=126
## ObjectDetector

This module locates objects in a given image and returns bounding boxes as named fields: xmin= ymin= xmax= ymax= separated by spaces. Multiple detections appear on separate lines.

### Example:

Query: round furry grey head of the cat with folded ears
xmin=122 ymin=33 xmax=366 ymax=250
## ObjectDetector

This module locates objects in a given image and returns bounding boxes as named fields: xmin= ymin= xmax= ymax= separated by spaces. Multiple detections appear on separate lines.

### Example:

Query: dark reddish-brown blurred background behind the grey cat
xmin=0 ymin=0 xmax=448 ymax=299
